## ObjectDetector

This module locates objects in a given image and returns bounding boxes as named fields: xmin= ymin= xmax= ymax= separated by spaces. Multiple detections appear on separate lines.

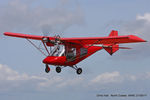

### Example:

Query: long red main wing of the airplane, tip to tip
xmin=4 ymin=31 xmax=146 ymax=45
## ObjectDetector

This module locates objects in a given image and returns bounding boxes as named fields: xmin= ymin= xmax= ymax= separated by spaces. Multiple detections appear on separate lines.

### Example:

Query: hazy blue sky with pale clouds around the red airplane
xmin=0 ymin=0 xmax=150 ymax=100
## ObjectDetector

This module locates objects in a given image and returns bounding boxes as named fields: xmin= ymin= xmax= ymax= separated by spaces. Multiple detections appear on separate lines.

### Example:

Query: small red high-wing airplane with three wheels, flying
xmin=4 ymin=30 xmax=146 ymax=74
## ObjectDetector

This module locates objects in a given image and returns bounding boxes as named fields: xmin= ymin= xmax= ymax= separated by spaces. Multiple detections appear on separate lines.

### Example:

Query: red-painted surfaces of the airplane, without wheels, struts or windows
xmin=4 ymin=30 xmax=146 ymax=66
